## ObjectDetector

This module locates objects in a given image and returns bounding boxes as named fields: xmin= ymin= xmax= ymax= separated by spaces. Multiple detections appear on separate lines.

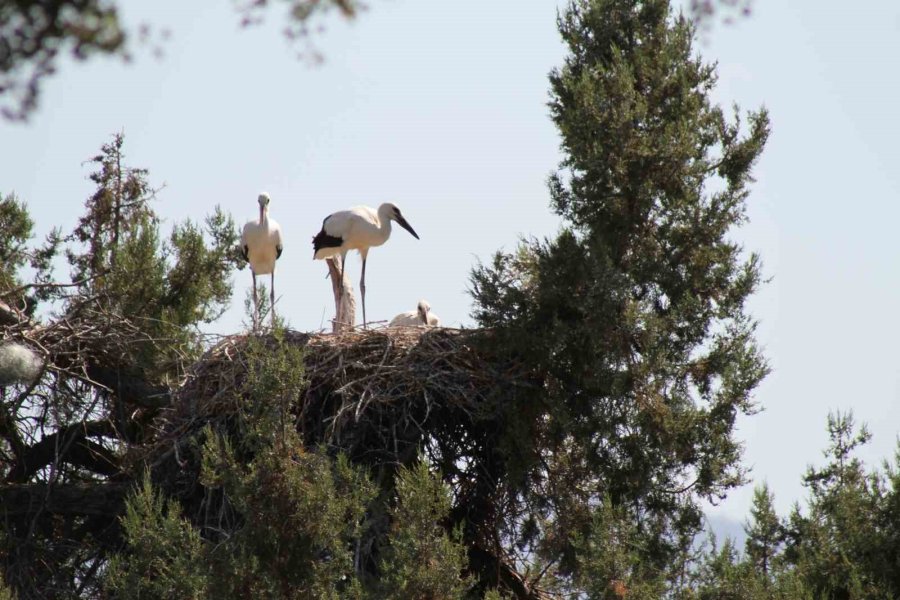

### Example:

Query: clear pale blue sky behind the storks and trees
xmin=0 ymin=0 xmax=900 ymax=519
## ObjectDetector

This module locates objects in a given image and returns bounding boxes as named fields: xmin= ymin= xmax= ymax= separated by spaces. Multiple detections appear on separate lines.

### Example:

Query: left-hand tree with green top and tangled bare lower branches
xmin=0 ymin=131 xmax=236 ymax=597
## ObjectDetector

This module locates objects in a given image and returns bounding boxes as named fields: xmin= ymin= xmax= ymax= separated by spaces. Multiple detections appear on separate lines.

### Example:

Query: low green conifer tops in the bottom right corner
xmin=678 ymin=413 xmax=900 ymax=600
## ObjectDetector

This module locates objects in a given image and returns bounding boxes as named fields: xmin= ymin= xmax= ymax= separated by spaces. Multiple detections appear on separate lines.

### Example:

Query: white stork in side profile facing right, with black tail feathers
xmin=313 ymin=202 xmax=419 ymax=327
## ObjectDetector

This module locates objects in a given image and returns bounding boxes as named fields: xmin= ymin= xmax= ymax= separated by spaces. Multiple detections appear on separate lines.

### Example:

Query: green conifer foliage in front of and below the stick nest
xmin=105 ymin=330 xmax=468 ymax=600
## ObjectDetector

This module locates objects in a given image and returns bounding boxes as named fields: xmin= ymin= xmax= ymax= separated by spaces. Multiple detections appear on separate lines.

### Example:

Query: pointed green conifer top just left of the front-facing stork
xmin=65 ymin=134 xmax=242 ymax=368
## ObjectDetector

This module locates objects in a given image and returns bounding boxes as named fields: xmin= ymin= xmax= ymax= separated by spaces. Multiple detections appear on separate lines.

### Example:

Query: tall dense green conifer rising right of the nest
xmin=472 ymin=0 xmax=769 ymax=592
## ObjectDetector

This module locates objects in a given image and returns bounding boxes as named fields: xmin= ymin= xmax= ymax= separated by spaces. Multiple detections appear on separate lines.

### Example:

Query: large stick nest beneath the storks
xmin=149 ymin=328 xmax=525 ymax=500
